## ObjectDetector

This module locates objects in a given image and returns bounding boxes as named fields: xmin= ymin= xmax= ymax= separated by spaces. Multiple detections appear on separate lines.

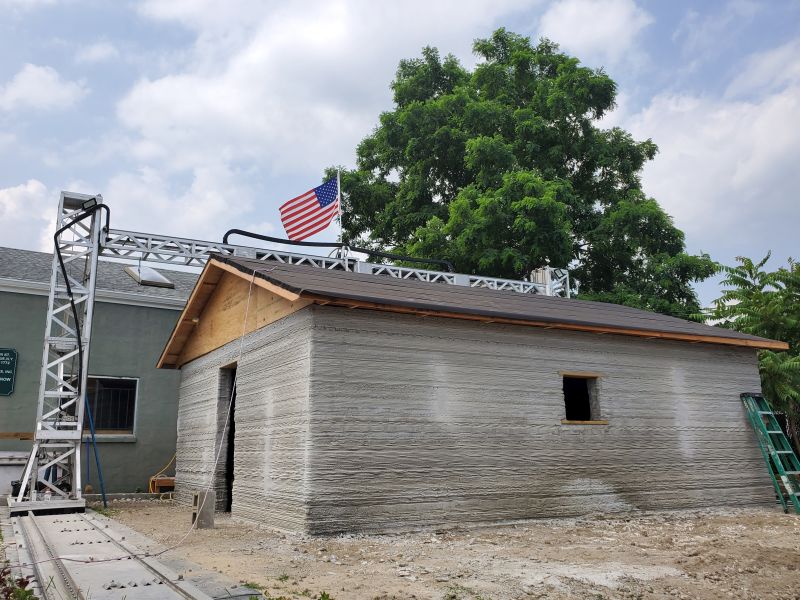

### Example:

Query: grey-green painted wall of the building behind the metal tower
xmin=0 ymin=292 xmax=180 ymax=492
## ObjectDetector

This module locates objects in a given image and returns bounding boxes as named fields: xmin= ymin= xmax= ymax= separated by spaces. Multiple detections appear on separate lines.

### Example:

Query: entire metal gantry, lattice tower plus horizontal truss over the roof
xmin=9 ymin=192 xmax=570 ymax=514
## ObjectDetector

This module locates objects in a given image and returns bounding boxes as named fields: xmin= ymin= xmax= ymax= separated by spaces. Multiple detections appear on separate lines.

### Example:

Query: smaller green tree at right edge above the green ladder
xmin=711 ymin=254 xmax=800 ymax=448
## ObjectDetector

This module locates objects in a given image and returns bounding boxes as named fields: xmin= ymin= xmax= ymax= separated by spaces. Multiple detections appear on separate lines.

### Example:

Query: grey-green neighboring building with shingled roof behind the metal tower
xmin=0 ymin=248 xmax=197 ymax=494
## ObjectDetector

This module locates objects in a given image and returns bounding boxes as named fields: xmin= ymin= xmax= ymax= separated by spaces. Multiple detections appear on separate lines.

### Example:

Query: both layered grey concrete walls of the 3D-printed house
xmin=172 ymin=306 xmax=773 ymax=534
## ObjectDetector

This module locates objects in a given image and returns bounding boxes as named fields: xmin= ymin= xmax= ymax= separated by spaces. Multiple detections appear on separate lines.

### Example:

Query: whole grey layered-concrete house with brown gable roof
xmin=159 ymin=257 xmax=784 ymax=533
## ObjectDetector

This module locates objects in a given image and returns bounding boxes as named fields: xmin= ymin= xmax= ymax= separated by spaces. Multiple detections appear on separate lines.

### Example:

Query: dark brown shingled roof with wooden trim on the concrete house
xmin=159 ymin=255 xmax=788 ymax=366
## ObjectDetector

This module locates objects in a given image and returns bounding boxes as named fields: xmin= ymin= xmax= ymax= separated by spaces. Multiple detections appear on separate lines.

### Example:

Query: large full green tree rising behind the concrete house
xmin=334 ymin=29 xmax=716 ymax=316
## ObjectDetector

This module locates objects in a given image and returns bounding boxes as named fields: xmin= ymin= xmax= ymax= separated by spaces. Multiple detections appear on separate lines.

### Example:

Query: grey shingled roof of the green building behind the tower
xmin=0 ymin=247 xmax=197 ymax=309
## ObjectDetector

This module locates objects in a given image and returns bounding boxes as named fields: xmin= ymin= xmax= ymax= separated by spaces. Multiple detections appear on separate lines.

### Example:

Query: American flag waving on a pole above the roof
xmin=280 ymin=177 xmax=339 ymax=241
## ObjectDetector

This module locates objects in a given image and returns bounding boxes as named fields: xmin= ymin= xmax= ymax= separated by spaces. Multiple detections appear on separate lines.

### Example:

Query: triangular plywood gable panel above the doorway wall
xmin=176 ymin=271 xmax=311 ymax=366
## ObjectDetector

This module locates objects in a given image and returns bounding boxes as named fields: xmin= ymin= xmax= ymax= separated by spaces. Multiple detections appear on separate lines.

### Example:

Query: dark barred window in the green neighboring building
xmin=83 ymin=376 xmax=139 ymax=435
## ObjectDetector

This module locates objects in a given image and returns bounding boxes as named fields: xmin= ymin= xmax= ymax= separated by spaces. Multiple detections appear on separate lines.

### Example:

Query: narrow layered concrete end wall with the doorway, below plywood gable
xmin=176 ymin=309 xmax=312 ymax=531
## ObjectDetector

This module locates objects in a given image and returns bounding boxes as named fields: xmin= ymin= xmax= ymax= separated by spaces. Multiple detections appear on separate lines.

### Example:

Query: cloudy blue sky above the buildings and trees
xmin=0 ymin=0 xmax=800 ymax=304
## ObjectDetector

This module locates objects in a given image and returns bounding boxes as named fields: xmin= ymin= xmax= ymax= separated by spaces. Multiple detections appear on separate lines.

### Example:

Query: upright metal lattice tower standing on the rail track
xmin=9 ymin=192 xmax=102 ymax=512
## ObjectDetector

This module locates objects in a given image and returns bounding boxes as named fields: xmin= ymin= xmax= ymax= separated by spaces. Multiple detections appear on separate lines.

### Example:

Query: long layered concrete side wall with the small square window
xmin=307 ymin=306 xmax=774 ymax=533
